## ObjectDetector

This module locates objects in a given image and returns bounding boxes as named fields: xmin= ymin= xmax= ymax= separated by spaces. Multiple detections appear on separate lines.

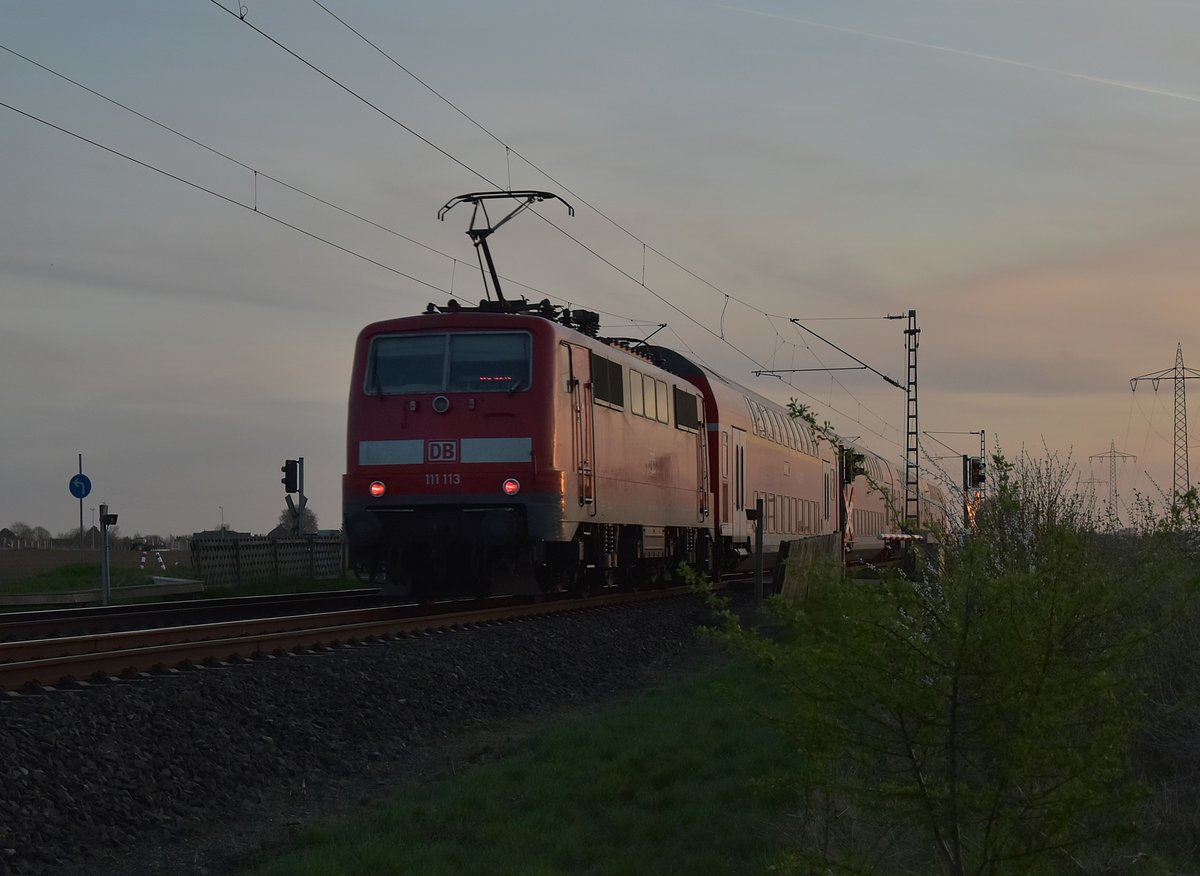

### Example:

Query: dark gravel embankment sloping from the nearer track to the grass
xmin=0 ymin=599 xmax=713 ymax=876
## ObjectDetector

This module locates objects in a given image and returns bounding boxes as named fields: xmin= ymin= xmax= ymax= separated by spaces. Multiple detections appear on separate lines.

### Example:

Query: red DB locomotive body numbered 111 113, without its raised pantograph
xmin=343 ymin=302 xmax=713 ymax=589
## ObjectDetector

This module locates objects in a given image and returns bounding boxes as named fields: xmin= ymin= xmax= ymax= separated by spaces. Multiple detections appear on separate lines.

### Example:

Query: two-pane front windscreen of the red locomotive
xmin=366 ymin=331 xmax=532 ymax=395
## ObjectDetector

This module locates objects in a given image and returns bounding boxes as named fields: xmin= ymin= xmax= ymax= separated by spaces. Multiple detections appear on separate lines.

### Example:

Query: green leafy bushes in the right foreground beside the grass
xmin=700 ymin=454 xmax=1198 ymax=876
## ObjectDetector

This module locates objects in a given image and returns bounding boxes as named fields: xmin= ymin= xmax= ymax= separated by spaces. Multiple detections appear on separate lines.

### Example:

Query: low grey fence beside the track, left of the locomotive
xmin=192 ymin=533 xmax=346 ymax=586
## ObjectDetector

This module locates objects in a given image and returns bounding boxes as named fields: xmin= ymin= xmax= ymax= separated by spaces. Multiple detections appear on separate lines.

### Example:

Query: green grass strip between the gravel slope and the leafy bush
xmin=241 ymin=661 xmax=794 ymax=876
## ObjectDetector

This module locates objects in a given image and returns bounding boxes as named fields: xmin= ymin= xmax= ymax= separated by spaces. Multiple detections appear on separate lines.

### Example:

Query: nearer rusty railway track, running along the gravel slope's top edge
xmin=0 ymin=587 xmax=691 ymax=695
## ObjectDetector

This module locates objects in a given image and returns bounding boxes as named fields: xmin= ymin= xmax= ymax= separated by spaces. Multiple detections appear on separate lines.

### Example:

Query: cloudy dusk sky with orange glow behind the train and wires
xmin=0 ymin=0 xmax=1200 ymax=535
